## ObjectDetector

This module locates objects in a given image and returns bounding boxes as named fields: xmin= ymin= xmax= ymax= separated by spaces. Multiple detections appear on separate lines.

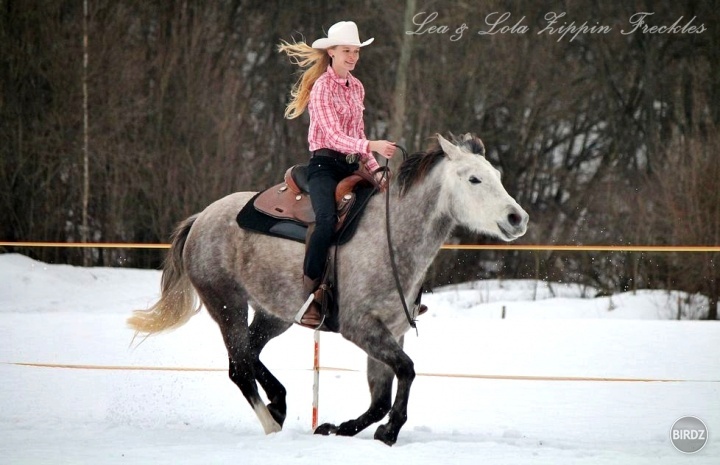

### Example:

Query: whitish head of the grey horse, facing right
xmin=437 ymin=134 xmax=529 ymax=241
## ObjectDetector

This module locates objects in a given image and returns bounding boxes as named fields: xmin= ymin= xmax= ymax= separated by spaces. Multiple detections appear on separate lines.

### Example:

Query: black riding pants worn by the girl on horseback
xmin=304 ymin=155 xmax=359 ymax=279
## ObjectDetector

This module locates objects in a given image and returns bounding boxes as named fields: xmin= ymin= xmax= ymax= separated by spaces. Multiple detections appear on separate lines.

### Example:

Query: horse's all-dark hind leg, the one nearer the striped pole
xmin=250 ymin=306 xmax=292 ymax=426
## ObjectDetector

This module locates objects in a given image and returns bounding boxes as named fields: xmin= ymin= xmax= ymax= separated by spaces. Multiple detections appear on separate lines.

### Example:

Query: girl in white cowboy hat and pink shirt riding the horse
xmin=279 ymin=21 xmax=395 ymax=328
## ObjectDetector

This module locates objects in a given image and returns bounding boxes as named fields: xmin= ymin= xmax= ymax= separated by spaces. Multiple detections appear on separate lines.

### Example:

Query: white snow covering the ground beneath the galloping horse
xmin=0 ymin=254 xmax=720 ymax=465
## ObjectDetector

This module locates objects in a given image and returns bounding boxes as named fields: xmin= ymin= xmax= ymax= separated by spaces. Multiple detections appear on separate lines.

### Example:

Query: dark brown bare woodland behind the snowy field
xmin=0 ymin=0 xmax=720 ymax=312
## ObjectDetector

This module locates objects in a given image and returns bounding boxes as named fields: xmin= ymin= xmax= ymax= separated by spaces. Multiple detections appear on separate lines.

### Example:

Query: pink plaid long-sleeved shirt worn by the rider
xmin=308 ymin=66 xmax=380 ymax=172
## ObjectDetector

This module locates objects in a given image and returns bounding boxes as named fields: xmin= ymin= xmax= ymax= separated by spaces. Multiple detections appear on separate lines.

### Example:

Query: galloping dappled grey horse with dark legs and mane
xmin=128 ymin=134 xmax=529 ymax=445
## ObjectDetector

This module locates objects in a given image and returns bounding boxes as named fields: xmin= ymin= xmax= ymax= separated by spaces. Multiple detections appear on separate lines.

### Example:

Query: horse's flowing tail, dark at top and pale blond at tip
xmin=127 ymin=215 xmax=200 ymax=336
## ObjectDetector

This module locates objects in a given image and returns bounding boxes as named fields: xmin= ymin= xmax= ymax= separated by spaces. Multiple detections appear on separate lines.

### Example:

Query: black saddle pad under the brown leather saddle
xmin=237 ymin=187 xmax=377 ymax=245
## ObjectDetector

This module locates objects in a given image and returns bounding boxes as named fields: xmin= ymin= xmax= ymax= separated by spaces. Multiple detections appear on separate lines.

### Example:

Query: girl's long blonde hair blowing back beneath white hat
xmin=278 ymin=40 xmax=330 ymax=119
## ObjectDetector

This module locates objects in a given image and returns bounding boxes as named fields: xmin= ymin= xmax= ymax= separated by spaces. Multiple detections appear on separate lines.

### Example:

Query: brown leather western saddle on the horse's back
xmin=254 ymin=164 xmax=377 ymax=231
